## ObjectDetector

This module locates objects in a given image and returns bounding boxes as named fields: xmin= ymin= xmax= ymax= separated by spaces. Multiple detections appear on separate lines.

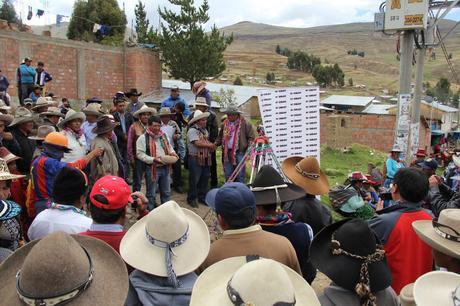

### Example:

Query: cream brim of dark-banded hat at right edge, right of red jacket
xmin=412 ymin=220 xmax=460 ymax=259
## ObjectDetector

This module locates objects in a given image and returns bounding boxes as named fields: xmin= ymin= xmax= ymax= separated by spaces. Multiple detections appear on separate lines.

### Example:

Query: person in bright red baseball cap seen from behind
xmin=80 ymin=176 xmax=148 ymax=253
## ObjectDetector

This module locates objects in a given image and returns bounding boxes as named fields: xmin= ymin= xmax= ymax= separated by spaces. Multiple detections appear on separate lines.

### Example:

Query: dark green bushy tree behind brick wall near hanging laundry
xmin=67 ymin=0 xmax=126 ymax=46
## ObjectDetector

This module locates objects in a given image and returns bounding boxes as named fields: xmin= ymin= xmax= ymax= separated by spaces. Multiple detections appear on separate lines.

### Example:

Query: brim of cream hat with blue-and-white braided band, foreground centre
xmin=120 ymin=208 xmax=210 ymax=277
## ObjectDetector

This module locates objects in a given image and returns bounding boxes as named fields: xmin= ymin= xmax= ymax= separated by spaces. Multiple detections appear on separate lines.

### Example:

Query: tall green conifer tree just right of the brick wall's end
xmin=154 ymin=0 xmax=233 ymax=87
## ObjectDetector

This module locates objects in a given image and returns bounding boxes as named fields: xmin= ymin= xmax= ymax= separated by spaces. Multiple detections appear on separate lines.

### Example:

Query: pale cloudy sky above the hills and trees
xmin=13 ymin=0 xmax=460 ymax=28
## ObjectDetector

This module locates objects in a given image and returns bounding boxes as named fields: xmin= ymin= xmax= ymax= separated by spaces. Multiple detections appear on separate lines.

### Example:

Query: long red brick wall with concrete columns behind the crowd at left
xmin=0 ymin=30 xmax=161 ymax=99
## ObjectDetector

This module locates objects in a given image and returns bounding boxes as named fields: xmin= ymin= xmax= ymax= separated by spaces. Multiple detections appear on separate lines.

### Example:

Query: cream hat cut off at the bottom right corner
xmin=414 ymin=271 xmax=460 ymax=306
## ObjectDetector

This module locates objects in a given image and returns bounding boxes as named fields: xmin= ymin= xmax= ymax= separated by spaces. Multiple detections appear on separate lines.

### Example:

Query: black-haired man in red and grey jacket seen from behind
xmin=369 ymin=168 xmax=433 ymax=294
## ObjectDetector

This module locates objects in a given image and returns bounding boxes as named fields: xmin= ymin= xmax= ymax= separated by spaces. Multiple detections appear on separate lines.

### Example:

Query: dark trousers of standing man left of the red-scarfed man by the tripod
xmin=187 ymin=156 xmax=210 ymax=203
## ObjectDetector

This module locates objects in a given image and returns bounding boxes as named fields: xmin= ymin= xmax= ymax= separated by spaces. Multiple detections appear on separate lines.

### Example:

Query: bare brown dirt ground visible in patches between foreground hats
xmin=127 ymin=191 xmax=330 ymax=294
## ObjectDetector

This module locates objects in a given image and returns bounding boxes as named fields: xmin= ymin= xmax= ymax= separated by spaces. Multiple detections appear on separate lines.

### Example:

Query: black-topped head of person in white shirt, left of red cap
xmin=53 ymin=167 xmax=88 ymax=205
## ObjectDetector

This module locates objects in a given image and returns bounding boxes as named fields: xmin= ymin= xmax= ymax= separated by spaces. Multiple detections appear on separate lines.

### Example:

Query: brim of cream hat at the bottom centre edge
xmin=190 ymin=256 xmax=320 ymax=306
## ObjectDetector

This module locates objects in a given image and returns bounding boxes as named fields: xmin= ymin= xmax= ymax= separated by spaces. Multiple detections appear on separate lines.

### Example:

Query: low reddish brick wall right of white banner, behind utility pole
xmin=320 ymin=113 xmax=429 ymax=152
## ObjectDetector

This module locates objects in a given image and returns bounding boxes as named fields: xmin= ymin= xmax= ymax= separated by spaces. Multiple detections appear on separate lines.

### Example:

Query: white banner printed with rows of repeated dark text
xmin=258 ymin=86 xmax=320 ymax=162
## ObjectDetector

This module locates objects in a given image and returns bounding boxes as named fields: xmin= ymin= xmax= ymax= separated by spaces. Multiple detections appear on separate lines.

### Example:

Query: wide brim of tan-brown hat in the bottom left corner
xmin=0 ymin=235 xmax=129 ymax=306
